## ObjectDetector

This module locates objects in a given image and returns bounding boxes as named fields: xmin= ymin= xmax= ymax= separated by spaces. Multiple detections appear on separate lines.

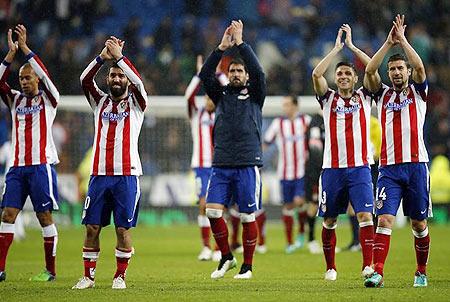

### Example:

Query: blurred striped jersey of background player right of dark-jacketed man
xmin=264 ymin=114 xmax=311 ymax=180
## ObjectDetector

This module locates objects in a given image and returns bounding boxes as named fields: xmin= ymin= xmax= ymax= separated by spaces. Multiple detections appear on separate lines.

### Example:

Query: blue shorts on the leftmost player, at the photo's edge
xmin=2 ymin=164 xmax=59 ymax=213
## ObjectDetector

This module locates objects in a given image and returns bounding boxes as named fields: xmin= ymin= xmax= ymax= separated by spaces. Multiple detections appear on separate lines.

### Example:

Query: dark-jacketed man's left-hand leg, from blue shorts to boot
xmin=206 ymin=168 xmax=236 ymax=279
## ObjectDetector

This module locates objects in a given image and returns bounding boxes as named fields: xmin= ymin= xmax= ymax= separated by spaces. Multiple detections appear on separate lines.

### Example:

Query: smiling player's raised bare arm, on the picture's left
xmin=312 ymin=29 xmax=344 ymax=97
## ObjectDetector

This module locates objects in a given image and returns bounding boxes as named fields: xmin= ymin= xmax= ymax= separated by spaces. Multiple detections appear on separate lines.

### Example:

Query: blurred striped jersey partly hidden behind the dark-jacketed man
xmin=185 ymin=75 xmax=215 ymax=168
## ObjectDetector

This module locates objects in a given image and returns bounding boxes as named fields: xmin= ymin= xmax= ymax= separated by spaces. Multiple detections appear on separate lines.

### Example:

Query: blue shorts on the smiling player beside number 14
xmin=318 ymin=166 xmax=373 ymax=217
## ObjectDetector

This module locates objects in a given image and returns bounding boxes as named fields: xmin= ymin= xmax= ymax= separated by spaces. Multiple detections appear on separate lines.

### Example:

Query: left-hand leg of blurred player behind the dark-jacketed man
xmin=194 ymin=168 xmax=212 ymax=261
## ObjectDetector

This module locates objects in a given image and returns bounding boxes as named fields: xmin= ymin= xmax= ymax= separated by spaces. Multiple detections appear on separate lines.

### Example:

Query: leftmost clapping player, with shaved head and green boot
xmin=0 ymin=24 xmax=59 ymax=281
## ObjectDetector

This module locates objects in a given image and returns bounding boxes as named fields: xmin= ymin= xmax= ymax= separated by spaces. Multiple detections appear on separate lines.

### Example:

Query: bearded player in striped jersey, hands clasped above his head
xmin=72 ymin=37 xmax=147 ymax=289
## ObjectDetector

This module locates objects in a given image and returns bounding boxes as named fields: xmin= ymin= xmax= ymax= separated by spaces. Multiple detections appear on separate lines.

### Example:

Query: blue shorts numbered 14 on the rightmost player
xmin=375 ymin=163 xmax=432 ymax=220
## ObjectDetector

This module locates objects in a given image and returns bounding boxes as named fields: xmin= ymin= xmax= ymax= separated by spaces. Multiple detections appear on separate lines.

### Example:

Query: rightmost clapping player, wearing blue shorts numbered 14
xmin=364 ymin=15 xmax=432 ymax=287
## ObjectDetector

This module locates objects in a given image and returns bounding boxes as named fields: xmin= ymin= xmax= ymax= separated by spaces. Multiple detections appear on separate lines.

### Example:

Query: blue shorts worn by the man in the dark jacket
xmin=206 ymin=166 xmax=261 ymax=213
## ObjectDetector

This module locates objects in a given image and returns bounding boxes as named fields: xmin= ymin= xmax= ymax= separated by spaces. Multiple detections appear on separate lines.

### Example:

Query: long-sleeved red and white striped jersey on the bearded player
xmin=80 ymin=57 xmax=147 ymax=175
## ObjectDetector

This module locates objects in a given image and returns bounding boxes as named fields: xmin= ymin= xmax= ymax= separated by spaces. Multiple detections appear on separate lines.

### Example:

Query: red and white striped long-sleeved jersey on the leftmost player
xmin=0 ymin=52 xmax=59 ymax=167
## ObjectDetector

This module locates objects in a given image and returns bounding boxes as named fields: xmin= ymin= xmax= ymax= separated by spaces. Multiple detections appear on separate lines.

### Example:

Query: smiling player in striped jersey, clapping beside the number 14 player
xmin=312 ymin=24 xmax=373 ymax=281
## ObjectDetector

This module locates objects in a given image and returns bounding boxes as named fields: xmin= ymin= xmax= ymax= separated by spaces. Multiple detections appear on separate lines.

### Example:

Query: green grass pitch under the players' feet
xmin=0 ymin=223 xmax=450 ymax=302
